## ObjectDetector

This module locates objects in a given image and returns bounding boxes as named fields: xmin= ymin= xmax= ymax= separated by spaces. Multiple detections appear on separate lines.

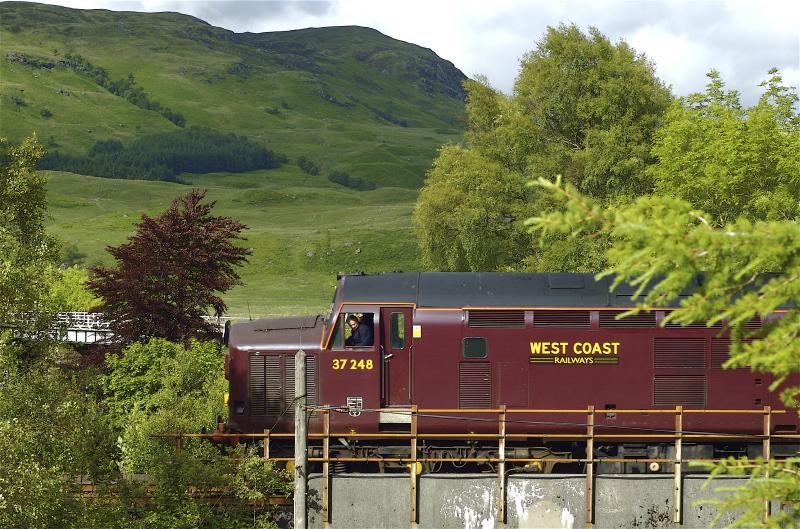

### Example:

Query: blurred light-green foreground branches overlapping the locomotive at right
xmin=526 ymin=178 xmax=800 ymax=528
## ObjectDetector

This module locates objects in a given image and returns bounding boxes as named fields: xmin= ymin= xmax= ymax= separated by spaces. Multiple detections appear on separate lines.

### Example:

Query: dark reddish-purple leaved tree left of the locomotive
xmin=89 ymin=189 xmax=252 ymax=343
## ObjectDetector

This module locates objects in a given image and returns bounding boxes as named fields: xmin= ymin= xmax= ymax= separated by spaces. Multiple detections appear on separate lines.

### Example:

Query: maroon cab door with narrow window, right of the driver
xmin=381 ymin=307 xmax=413 ymax=406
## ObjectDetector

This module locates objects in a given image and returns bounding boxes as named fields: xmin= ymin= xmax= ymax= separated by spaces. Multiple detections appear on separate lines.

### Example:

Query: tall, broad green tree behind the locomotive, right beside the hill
xmin=415 ymin=25 xmax=671 ymax=271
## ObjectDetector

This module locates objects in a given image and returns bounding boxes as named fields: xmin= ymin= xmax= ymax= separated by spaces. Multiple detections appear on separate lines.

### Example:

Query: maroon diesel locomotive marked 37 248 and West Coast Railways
xmin=225 ymin=273 xmax=800 ymax=471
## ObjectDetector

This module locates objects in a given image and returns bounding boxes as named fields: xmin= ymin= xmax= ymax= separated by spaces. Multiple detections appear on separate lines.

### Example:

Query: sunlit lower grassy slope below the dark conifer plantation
xmin=47 ymin=166 xmax=417 ymax=317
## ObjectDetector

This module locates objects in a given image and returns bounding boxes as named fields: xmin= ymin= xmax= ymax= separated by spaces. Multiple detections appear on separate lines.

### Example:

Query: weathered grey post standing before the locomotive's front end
xmin=294 ymin=349 xmax=308 ymax=529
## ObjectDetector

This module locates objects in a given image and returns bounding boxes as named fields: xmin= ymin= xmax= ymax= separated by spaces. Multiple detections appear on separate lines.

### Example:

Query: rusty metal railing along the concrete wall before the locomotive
xmin=151 ymin=406 xmax=800 ymax=527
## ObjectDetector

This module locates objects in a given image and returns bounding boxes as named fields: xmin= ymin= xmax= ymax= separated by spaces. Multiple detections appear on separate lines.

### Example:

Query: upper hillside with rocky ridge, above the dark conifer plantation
xmin=0 ymin=2 xmax=465 ymax=188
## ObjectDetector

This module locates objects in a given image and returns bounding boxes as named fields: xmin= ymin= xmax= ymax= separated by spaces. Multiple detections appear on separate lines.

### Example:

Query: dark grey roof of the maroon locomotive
xmin=339 ymin=272 xmax=701 ymax=308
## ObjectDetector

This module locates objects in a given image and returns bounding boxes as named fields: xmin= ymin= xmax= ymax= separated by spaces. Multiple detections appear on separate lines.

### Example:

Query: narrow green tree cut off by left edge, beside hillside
xmin=0 ymin=136 xmax=57 ymax=321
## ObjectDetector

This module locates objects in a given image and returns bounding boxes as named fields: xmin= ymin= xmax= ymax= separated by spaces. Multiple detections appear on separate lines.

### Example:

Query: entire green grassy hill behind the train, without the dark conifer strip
xmin=0 ymin=2 xmax=465 ymax=316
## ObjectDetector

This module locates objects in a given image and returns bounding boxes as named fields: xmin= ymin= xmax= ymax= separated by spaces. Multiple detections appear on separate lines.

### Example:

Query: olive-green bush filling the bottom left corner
xmin=0 ymin=343 xmax=116 ymax=529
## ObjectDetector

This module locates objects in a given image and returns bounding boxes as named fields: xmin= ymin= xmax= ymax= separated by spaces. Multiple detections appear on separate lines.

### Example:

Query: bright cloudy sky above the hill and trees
xmin=34 ymin=0 xmax=800 ymax=104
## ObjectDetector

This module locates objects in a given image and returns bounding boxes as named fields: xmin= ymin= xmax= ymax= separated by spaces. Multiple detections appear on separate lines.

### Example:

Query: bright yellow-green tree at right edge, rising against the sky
xmin=649 ymin=69 xmax=800 ymax=225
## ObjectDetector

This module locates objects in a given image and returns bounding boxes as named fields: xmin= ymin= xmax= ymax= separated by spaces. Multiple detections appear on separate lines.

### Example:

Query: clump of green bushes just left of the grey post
xmin=99 ymin=339 xmax=288 ymax=529
